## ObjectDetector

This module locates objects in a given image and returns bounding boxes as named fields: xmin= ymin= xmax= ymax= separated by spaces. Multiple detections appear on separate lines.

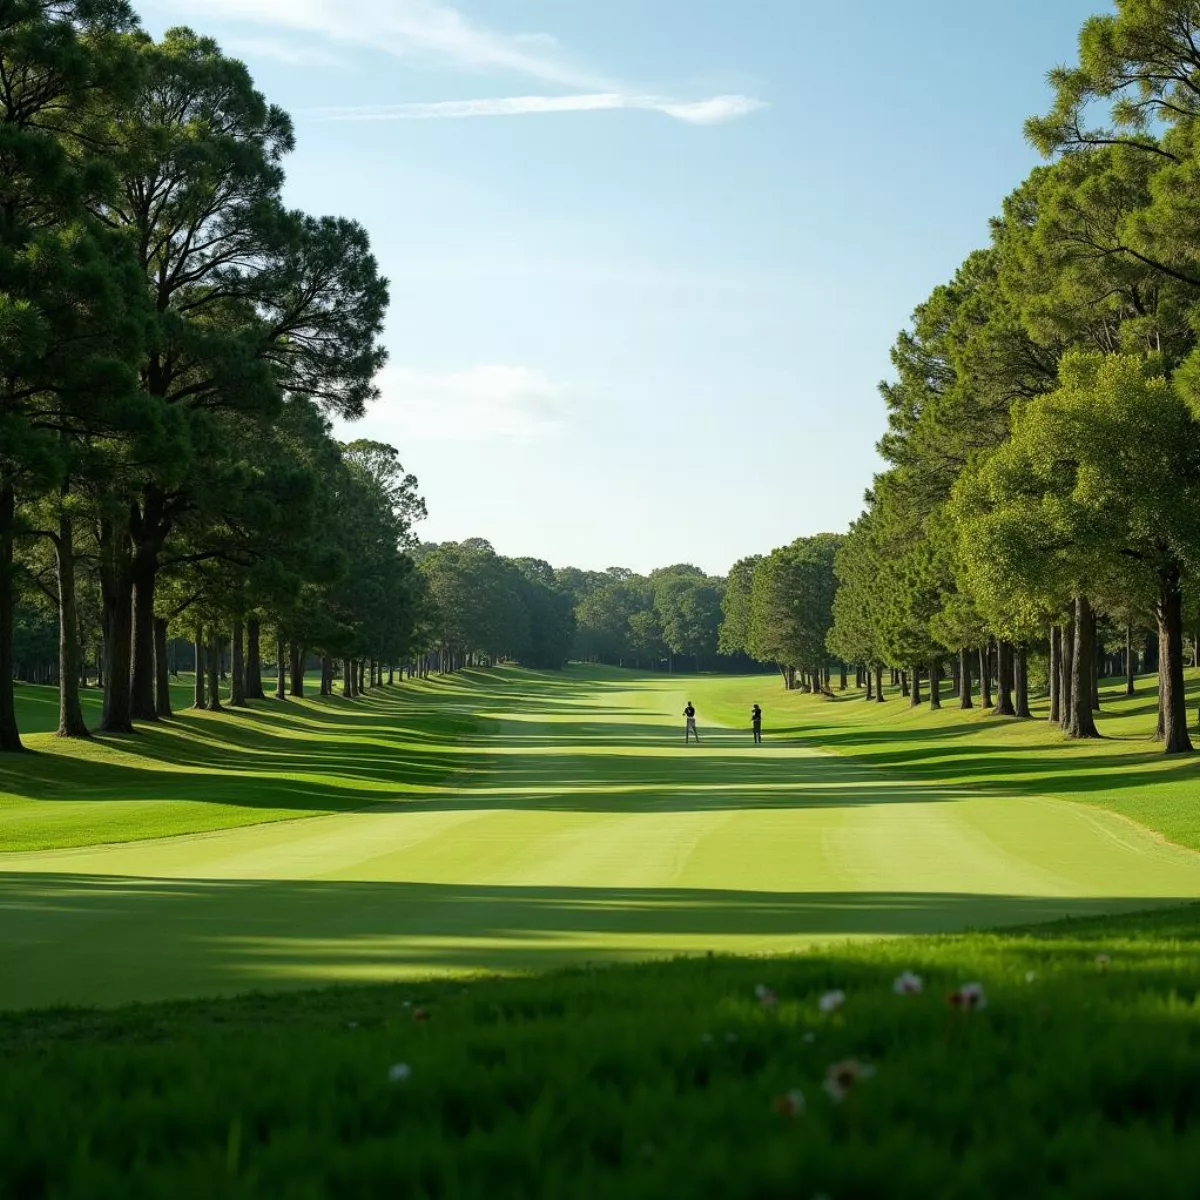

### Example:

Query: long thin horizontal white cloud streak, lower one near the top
xmin=314 ymin=91 xmax=763 ymax=125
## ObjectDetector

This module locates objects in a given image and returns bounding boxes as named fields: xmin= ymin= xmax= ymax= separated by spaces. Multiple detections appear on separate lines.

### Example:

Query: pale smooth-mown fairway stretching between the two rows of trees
xmin=0 ymin=668 xmax=1200 ymax=1008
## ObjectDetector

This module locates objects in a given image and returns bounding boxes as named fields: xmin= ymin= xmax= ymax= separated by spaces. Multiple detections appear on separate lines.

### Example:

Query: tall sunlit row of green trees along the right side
xmin=829 ymin=0 xmax=1200 ymax=754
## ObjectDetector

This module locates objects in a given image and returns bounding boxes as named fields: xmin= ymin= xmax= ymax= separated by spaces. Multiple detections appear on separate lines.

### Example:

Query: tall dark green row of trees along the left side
xmin=0 ymin=0 xmax=424 ymax=750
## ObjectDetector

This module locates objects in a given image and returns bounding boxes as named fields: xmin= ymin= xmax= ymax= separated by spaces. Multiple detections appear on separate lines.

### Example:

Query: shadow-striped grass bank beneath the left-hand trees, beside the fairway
xmin=0 ymin=679 xmax=476 ymax=851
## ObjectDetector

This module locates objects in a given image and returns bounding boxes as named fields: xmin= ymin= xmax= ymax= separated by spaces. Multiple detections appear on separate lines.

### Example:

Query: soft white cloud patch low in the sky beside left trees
xmin=368 ymin=365 xmax=563 ymax=446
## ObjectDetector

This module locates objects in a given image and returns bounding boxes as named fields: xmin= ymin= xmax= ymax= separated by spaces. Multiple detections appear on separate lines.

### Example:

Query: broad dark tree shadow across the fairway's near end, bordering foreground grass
xmin=0 ymin=872 xmax=1180 ymax=1008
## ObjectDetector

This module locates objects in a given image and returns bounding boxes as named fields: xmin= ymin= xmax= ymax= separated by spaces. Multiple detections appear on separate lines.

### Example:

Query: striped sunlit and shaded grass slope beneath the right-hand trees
xmin=691 ymin=671 xmax=1200 ymax=850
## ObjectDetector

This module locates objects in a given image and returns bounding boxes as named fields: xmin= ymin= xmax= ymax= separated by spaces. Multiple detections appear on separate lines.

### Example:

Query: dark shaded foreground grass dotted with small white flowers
xmin=0 ymin=907 xmax=1200 ymax=1200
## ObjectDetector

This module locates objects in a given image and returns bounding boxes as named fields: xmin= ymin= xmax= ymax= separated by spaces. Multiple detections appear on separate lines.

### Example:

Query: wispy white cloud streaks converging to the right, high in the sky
xmin=151 ymin=0 xmax=764 ymax=125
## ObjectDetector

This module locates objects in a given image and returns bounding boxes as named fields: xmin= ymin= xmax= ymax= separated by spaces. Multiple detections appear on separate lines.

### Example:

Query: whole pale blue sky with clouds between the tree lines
xmin=142 ymin=0 xmax=1104 ymax=572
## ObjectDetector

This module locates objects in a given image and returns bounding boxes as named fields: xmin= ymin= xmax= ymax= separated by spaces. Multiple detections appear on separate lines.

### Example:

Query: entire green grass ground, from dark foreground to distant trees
xmin=7 ymin=668 xmax=1200 ymax=1200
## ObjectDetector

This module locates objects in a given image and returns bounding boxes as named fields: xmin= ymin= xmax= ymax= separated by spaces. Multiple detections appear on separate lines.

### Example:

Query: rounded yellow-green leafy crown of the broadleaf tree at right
xmin=954 ymin=355 xmax=1200 ymax=623
